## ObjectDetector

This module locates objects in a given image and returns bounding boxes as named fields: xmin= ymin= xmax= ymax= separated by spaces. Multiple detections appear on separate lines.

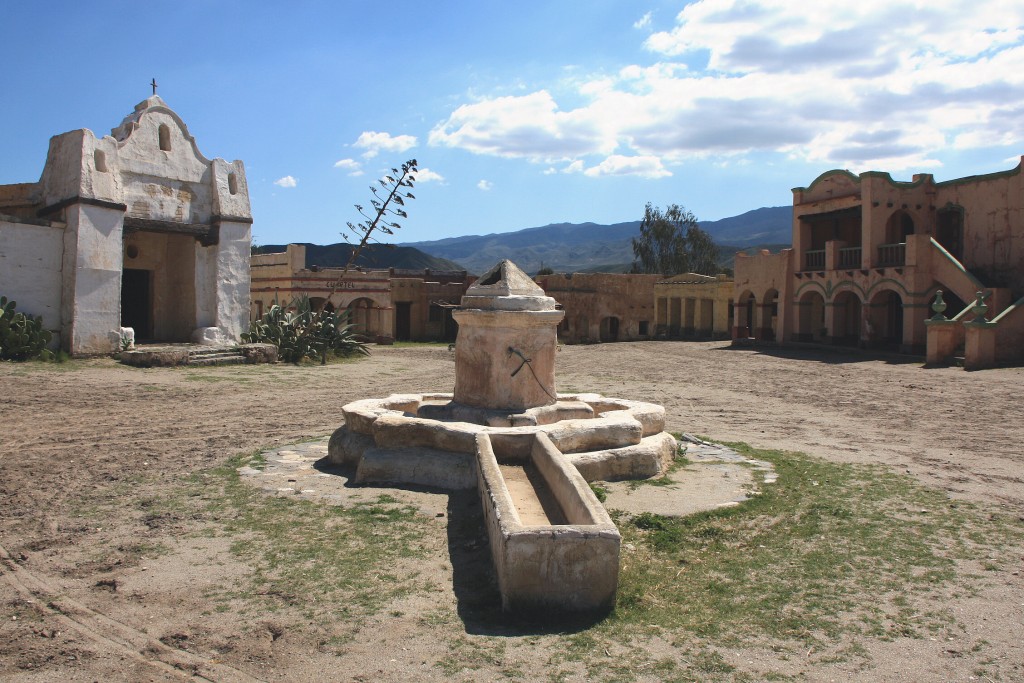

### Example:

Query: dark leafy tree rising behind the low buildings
xmin=633 ymin=202 xmax=719 ymax=275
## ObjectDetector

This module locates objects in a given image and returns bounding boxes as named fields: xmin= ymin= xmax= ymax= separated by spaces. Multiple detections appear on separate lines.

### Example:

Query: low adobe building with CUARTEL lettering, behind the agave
xmin=250 ymin=245 xmax=473 ymax=342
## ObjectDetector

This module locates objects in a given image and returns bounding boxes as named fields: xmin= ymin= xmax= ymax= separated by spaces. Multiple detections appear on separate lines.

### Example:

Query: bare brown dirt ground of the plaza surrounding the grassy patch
xmin=0 ymin=342 xmax=1024 ymax=681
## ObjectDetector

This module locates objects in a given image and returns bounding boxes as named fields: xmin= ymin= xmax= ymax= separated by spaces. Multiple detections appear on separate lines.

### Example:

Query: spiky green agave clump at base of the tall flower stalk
xmin=242 ymin=295 xmax=370 ymax=364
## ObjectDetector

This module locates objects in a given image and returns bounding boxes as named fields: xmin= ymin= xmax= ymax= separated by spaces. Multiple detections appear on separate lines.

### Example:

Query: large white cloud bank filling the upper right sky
xmin=429 ymin=0 xmax=1024 ymax=177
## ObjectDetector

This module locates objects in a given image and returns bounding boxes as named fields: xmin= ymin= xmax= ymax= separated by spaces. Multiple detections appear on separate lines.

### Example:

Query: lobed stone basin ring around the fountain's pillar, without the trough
xmin=328 ymin=393 xmax=677 ymax=489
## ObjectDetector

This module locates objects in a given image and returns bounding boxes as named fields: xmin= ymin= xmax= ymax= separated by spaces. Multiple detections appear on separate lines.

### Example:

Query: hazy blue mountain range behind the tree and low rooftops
xmin=400 ymin=206 xmax=793 ymax=274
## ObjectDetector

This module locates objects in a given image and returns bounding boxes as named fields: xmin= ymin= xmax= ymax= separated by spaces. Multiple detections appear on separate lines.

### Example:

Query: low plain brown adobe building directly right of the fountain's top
xmin=537 ymin=272 xmax=664 ymax=344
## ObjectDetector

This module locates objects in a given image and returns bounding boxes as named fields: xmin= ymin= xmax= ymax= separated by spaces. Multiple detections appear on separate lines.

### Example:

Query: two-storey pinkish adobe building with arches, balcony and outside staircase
xmin=733 ymin=157 xmax=1024 ymax=367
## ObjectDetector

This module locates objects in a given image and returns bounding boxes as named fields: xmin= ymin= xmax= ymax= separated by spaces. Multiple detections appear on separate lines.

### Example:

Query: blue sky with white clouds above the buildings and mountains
xmin=0 ymin=0 xmax=1024 ymax=244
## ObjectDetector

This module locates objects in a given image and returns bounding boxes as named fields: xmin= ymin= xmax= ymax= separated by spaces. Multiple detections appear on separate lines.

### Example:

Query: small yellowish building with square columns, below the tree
xmin=654 ymin=272 xmax=733 ymax=339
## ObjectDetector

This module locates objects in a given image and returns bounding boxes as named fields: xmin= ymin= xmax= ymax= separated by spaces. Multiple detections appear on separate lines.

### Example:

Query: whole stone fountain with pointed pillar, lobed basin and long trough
xmin=328 ymin=260 xmax=677 ymax=611
